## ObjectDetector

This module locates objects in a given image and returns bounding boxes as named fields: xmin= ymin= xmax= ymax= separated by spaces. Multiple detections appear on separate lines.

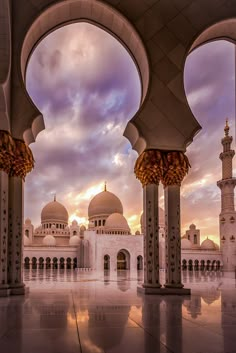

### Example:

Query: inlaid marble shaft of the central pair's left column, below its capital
xmin=143 ymin=184 xmax=161 ymax=288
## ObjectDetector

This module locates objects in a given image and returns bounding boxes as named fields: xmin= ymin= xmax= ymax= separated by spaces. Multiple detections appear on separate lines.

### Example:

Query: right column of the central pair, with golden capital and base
xmin=161 ymin=151 xmax=190 ymax=294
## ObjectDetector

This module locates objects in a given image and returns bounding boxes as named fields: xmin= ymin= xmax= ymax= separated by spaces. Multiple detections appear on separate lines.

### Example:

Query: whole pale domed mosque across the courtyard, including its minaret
xmin=24 ymin=121 xmax=236 ymax=271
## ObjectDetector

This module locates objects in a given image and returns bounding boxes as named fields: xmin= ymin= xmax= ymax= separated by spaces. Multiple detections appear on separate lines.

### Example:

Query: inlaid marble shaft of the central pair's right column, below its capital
xmin=164 ymin=185 xmax=183 ymax=288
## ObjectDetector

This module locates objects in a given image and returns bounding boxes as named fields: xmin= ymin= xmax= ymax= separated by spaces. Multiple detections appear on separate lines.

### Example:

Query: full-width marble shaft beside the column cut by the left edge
xmin=8 ymin=176 xmax=25 ymax=295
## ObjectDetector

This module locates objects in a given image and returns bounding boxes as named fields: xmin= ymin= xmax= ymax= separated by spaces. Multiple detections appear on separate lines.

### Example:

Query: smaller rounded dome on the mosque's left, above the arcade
xmin=41 ymin=200 xmax=68 ymax=223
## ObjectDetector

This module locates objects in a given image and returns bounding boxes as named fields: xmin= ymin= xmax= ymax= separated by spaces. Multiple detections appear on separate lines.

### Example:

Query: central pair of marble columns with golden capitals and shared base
xmin=134 ymin=149 xmax=190 ymax=294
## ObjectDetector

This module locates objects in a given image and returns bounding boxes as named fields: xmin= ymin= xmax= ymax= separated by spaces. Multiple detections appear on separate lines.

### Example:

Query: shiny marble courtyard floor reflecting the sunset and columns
xmin=0 ymin=270 xmax=236 ymax=353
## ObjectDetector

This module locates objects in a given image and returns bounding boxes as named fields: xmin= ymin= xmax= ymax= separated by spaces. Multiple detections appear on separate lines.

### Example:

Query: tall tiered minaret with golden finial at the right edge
xmin=217 ymin=119 xmax=236 ymax=271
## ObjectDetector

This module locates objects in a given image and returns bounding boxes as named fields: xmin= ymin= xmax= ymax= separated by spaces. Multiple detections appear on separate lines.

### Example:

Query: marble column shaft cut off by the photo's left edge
xmin=0 ymin=171 xmax=10 ymax=297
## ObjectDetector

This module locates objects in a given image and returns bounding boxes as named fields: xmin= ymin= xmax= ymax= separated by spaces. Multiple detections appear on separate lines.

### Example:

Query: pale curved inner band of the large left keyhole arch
xmin=19 ymin=0 xmax=150 ymax=144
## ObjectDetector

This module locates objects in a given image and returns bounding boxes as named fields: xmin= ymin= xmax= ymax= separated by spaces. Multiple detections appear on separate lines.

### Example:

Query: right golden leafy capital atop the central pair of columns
xmin=161 ymin=151 xmax=191 ymax=187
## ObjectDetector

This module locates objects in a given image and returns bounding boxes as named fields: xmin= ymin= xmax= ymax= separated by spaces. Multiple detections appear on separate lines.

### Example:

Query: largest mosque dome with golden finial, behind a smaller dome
xmin=88 ymin=190 xmax=123 ymax=219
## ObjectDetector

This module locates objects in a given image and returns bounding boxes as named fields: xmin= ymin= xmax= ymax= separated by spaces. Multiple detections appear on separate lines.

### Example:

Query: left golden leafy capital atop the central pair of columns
xmin=134 ymin=150 xmax=164 ymax=187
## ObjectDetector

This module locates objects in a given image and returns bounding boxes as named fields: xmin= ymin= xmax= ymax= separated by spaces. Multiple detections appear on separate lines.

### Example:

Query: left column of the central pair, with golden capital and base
xmin=134 ymin=150 xmax=162 ymax=294
